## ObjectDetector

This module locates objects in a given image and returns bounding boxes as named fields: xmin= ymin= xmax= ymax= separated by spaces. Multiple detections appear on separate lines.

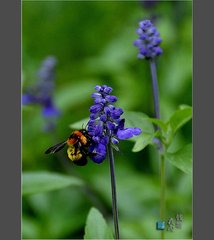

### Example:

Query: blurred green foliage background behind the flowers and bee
xmin=22 ymin=1 xmax=192 ymax=239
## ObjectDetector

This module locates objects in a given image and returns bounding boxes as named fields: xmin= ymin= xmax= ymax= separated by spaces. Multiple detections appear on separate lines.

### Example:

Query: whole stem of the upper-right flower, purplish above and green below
xmin=150 ymin=59 xmax=166 ymax=239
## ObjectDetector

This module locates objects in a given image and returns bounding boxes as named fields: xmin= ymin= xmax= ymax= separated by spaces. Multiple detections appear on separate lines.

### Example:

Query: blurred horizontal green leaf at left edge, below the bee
xmin=22 ymin=172 xmax=83 ymax=195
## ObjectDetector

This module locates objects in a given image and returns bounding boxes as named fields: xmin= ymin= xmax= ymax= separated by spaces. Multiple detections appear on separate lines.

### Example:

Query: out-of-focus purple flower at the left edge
xmin=22 ymin=56 xmax=60 ymax=130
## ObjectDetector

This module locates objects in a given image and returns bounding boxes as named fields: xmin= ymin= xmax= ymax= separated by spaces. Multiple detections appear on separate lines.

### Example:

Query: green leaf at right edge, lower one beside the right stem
xmin=166 ymin=144 xmax=192 ymax=174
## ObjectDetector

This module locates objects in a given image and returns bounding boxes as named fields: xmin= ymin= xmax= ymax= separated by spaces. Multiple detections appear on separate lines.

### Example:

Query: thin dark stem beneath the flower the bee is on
xmin=107 ymin=145 xmax=120 ymax=239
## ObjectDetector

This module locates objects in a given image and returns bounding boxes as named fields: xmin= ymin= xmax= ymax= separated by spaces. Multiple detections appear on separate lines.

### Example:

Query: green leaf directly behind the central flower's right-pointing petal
xmin=124 ymin=112 xmax=154 ymax=152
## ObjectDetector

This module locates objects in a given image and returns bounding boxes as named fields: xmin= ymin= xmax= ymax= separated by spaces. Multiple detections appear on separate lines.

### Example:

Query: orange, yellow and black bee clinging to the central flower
xmin=45 ymin=129 xmax=92 ymax=166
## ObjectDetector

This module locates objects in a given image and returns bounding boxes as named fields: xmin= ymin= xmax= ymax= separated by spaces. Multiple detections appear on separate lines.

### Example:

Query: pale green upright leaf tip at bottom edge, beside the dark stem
xmin=84 ymin=207 xmax=113 ymax=239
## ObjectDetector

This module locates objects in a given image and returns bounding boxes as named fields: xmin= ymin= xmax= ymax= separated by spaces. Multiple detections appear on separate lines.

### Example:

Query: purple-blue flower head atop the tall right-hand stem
xmin=134 ymin=20 xmax=163 ymax=59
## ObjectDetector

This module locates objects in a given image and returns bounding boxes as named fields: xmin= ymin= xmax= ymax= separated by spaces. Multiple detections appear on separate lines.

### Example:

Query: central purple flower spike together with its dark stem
xmin=88 ymin=85 xmax=142 ymax=239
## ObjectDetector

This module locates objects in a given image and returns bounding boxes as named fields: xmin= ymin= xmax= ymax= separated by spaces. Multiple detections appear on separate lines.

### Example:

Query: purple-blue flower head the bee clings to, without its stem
xmin=88 ymin=85 xmax=141 ymax=163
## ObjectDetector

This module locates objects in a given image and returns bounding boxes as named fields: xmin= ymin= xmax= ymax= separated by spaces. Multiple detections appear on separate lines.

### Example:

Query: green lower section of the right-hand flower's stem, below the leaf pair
xmin=160 ymin=154 xmax=166 ymax=239
